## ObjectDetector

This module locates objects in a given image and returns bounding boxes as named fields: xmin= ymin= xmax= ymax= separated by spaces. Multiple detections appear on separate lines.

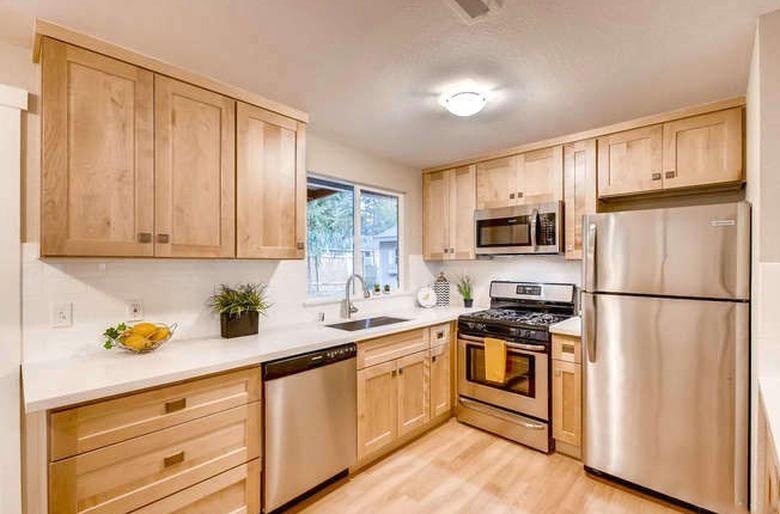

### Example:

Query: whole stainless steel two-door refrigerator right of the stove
xmin=582 ymin=202 xmax=750 ymax=513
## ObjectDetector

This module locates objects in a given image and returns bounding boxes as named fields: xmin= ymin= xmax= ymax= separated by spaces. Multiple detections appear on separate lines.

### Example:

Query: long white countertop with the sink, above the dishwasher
xmin=22 ymin=307 xmax=478 ymax=413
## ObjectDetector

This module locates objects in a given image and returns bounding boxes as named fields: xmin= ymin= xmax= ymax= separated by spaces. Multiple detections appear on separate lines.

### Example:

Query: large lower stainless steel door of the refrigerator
xmin=583 ymin=294 xmax=749 ymax=513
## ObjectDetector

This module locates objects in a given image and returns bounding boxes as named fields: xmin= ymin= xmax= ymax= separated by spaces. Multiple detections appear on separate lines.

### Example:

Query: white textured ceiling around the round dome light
xmin=0 ymin=0 xmax=780 ymax=167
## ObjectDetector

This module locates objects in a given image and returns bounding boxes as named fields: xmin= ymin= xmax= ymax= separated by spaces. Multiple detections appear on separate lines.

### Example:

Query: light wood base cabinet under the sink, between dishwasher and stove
xmin=357 ymin=324 xmax=452 ymax=465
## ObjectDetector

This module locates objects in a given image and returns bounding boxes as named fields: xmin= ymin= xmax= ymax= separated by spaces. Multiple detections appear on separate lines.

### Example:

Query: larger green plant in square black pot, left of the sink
xmin=209 ymin=283 xmax=271 ymax=338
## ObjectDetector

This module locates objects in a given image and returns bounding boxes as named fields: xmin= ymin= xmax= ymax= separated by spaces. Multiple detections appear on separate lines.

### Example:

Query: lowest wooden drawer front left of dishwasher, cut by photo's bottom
xmin=133 ymin=459 xmax=260 ymax=514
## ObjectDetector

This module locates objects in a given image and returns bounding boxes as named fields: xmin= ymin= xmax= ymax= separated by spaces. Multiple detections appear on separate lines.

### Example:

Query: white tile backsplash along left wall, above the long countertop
xmin=22 ymin=243 xmax=436 ymax=362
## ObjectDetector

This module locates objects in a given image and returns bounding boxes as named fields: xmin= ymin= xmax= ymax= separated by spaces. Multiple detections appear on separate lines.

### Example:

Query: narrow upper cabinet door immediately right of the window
xmin=423 ymin=171 xmax=450 ymax=261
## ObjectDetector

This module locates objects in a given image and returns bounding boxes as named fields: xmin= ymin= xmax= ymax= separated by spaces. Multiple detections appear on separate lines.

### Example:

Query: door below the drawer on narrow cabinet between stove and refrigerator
xmin=551 ymin=360 xmax=582 ymax=446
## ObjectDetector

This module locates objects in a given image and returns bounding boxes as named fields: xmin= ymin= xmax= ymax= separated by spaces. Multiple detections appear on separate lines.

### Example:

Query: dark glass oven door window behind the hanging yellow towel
xmin=466 ymin=344 xmax=536 ymax=398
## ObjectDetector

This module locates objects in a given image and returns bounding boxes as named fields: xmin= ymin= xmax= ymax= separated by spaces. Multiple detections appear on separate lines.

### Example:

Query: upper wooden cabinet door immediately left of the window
xmin=236 ymin=102 xmax=306 ymax=259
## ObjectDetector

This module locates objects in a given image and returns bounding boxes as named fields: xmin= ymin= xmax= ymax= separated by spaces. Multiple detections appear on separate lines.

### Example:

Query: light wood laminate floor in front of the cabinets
xmin=288 ymin=419 xmax=685 ymax=514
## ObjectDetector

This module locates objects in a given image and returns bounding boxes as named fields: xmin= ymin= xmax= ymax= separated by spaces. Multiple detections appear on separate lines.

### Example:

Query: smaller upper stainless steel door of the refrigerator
xmin=583 ymin=202 xmax=750 ymax=300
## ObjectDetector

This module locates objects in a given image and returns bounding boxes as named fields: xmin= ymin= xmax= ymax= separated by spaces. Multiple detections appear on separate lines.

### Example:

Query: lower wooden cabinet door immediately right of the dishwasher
xmin=357 ymin=361 xmax=398 ymax=460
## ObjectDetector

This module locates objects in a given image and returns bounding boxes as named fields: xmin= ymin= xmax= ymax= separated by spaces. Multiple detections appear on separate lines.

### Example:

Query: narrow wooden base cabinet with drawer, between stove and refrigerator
xmin=552 ymin=335 xmax=582 ymax=458
